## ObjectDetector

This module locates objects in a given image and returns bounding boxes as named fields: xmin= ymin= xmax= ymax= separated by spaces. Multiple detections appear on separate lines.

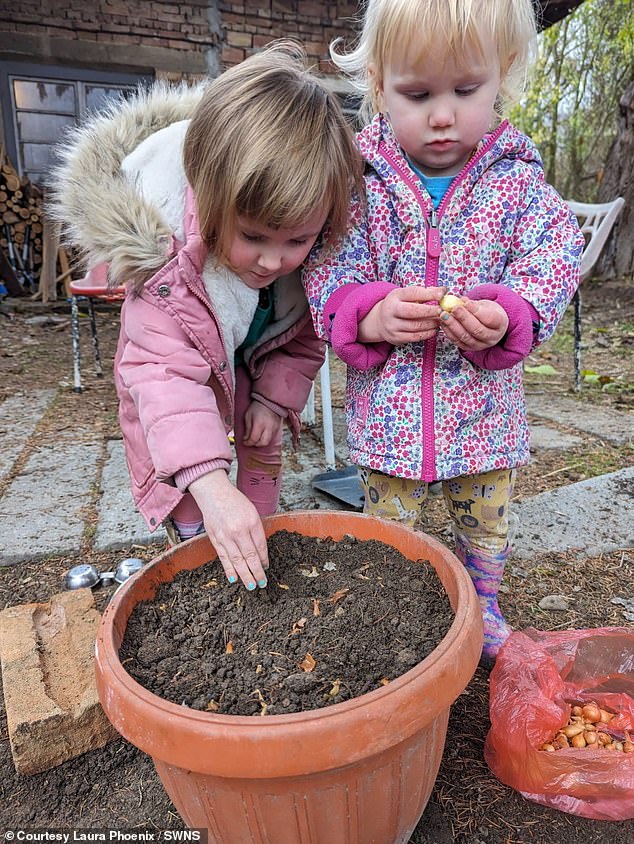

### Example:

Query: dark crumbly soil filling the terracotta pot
xmin=120 ymin=531 xmax=453 ymax=715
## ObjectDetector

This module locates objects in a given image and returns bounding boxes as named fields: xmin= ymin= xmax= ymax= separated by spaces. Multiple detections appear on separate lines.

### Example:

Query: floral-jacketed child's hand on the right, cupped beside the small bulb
xmin=440 ymin=299 xmax=509 ymax=352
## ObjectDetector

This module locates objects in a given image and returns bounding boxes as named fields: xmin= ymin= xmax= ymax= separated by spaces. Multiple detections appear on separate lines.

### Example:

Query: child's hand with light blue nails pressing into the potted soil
xmin=189 ymin=469 xmax=269 ymax=589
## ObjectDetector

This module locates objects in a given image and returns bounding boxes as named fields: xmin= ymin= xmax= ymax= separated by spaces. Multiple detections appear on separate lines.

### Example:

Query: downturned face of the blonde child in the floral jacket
xmin=369 ymin=36 xmax=501 ymax=176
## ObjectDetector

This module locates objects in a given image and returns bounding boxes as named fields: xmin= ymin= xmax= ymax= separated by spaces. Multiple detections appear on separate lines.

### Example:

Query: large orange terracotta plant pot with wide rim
xmin=96 ymin=511 xmax=482 ymax=844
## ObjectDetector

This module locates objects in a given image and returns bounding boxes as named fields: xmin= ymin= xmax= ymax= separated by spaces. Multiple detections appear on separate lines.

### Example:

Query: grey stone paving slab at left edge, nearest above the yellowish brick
xmin=0 ymin=437 xmax=101 ymax=565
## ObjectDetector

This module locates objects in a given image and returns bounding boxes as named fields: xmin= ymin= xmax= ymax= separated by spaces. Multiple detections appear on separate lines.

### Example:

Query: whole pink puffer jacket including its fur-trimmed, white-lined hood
xmin=55 ymin=83 xmax=324 ymax=530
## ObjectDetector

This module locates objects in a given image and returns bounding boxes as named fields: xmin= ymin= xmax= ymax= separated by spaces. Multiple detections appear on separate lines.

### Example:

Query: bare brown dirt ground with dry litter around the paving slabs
xmin=0 ymin=274 xmax=634 ymax=844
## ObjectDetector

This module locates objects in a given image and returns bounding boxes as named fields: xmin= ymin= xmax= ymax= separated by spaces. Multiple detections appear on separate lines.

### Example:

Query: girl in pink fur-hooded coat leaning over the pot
xmin=55 ymin=44 xmax=361 ymax=589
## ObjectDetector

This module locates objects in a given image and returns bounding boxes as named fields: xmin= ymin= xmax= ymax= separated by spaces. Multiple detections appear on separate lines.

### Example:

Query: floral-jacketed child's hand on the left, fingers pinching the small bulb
xmin=357 ymin=285 xmax=445 ymax=346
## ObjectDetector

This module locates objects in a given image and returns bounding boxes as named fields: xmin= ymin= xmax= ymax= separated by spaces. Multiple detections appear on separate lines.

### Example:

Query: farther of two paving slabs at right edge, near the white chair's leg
xmin=526 ymin=393 xmax=634 ymax=445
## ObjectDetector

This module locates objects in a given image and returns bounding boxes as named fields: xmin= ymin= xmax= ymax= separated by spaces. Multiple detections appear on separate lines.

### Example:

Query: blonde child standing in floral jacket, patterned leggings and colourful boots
xmin=305 ymin=0 xmax=583 ymax=658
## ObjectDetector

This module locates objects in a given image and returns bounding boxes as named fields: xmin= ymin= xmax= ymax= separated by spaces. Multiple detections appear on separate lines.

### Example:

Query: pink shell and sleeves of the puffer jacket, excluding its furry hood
xmin=115 ymin=205 xmax=324 ymax=530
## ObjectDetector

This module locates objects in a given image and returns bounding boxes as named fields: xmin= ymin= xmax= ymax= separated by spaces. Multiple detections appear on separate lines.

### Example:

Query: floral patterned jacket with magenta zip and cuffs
xmin=303 ymin=115 xmax=584 ymax=481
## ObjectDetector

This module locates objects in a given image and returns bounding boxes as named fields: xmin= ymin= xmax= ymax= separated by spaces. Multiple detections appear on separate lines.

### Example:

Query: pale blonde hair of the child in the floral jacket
xmin=330 ymin=0 xmax=537 ymax=117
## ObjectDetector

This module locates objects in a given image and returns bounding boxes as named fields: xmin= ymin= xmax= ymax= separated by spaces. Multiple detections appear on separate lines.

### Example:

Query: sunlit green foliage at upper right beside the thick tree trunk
xmin=510 ymin=0 xmax=634 ymax=202
